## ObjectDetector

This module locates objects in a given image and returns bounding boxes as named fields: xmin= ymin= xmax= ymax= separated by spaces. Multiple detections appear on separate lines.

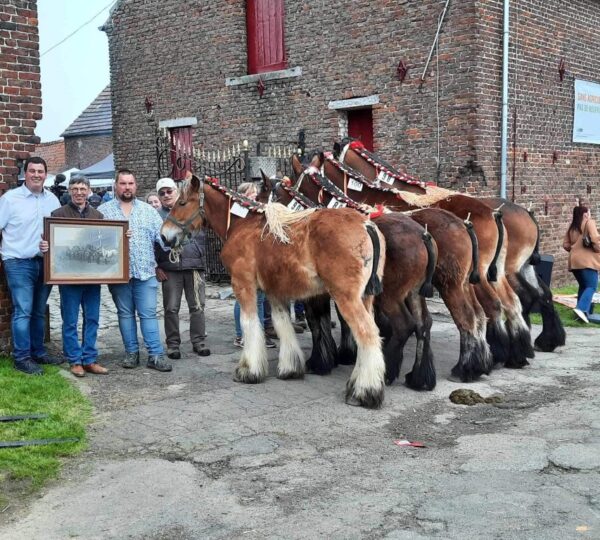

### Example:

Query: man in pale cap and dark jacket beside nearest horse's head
xmin=154 ymin=178 xmax=210 ymax=359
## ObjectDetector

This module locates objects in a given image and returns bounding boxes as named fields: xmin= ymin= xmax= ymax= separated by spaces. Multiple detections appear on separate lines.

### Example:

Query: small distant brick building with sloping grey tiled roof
xmin=61 ymin=86 xmax=112 ymax=169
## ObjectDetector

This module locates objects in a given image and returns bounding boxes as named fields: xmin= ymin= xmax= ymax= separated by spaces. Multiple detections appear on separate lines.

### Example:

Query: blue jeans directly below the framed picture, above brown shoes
xmin=58 ymin=285 xmax=100 ymax=366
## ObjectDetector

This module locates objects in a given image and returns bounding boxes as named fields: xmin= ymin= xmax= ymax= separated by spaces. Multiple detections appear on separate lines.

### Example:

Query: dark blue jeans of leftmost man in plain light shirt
xmin=3 ymin=257 xmax=52 ymax=362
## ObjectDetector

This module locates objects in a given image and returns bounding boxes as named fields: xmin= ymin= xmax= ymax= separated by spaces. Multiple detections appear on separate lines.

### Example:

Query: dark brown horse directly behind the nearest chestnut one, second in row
xmin=260 ymin=175 xmax=436 ymax=390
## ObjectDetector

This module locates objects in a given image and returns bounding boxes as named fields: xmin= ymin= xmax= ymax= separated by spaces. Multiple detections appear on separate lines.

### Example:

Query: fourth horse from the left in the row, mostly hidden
xmin=314 ymin=148 xmax=533 ymax=368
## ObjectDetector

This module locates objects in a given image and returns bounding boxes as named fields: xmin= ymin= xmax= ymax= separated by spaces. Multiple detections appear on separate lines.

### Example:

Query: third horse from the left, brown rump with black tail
xmin=288 ymin=167 xmax=493 ymax=381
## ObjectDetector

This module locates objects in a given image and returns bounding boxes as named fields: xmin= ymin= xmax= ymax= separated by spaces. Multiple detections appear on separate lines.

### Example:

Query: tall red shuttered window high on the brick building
xmin=246 ymin=0 xmax=287 ymax=74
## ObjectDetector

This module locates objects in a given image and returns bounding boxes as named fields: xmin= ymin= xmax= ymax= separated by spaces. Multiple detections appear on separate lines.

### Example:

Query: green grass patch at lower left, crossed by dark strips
xmin=0 ymin=357 xmax=92 ymax=493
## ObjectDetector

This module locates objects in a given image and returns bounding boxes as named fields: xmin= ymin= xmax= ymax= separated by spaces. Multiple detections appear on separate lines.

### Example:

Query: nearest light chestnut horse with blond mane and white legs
xmin=161 ymin=175 xmax=385 ymax=408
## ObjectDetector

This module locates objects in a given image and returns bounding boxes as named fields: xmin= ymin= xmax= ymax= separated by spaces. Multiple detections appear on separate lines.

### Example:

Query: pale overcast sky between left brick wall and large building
xmin=35 ymin=0 xmax=114 ymax=142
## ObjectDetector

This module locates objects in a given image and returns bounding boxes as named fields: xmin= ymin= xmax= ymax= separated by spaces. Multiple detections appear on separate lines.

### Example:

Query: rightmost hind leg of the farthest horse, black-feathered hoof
xmin=518 ymin=264 xmax=566 ymax=352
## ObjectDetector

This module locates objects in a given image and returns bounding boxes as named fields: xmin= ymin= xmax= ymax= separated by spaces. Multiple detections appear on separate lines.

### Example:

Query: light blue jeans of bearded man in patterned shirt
xmin=108 ymin=276 xmax=163 ymax=356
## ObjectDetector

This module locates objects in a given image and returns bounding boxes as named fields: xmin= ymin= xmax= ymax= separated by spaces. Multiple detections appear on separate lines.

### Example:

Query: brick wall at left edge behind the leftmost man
xmin=0 ymin=0 xmax=42 ymax=352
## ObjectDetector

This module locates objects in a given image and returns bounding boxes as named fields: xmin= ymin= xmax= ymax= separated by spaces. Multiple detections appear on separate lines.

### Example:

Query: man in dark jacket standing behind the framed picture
xmin=40 ymin=175 xmax=108 ymax=377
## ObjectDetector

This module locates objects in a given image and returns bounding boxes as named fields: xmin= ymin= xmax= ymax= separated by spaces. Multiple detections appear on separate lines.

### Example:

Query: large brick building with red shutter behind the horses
xmin=103 ymin=0 xmax=600 ymax=280
